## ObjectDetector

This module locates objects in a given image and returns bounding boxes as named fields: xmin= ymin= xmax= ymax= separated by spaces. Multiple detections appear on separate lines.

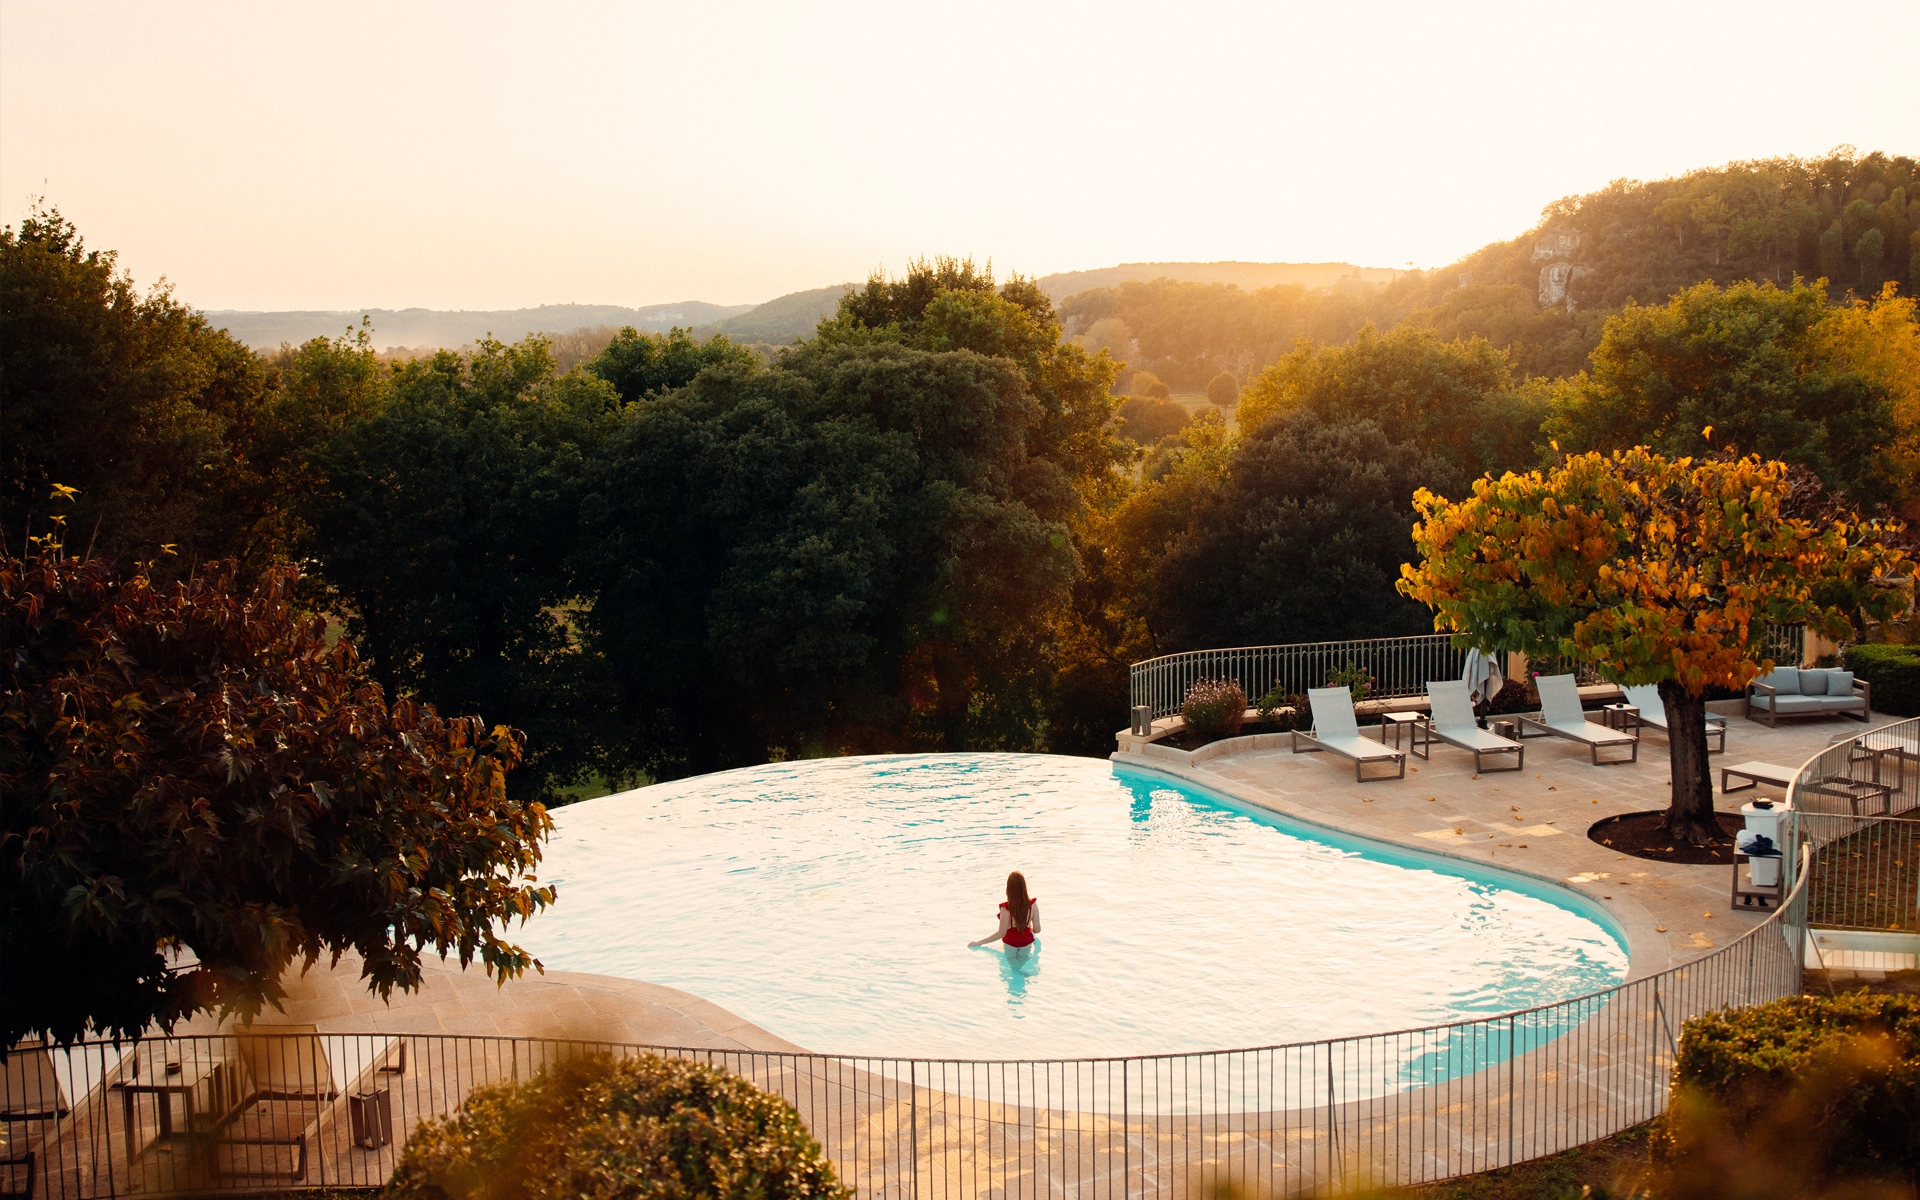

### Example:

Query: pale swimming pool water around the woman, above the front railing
xmin=511 ymin=755 xmax=1626 ymax=1058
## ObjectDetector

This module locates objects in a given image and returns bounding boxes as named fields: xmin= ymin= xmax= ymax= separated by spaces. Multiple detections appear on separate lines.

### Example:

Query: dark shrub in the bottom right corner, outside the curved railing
xmin=1663 ymin=993 xmax=1920 ymax=1196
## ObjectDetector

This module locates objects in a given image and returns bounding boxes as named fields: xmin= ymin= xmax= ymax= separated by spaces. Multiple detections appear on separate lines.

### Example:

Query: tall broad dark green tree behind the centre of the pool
xmin=582 ymin=341 xmax=1081 ymax=774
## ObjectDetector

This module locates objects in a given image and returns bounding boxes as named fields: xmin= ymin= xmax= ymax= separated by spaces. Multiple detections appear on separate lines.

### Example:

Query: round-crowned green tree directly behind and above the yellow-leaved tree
xmin=1548 ymin=282 xmax=1895 ymax=501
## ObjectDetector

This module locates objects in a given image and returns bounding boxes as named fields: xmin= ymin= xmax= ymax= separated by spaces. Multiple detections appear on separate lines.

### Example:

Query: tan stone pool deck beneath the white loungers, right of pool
xmin=1114 ymin=714 xmax=1850 ymax=979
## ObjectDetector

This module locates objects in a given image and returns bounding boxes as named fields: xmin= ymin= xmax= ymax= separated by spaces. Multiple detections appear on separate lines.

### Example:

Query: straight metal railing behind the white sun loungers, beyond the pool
xmin=1127 ymin=626 xmax=1807 ymax=720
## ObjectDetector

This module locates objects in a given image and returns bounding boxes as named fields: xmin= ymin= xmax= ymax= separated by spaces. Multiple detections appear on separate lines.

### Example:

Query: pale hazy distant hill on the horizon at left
xmin=207 ymin=300 xmax=748 ymax=349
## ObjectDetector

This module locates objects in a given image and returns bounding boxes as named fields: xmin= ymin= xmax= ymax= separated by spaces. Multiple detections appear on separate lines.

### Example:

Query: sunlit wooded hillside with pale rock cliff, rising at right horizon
xmin=1043 ymin=148 xmax=1920 ymax=390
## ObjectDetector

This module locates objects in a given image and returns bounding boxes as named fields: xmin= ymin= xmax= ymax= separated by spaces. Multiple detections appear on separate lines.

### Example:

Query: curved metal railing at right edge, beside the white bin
xmin=1784 ymin=720 xmax=1920 ymax=931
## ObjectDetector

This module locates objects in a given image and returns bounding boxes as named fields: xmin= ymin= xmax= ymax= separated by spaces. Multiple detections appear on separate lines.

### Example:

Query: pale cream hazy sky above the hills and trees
xmin=0 ymin=0 xmax=1920 ymax=309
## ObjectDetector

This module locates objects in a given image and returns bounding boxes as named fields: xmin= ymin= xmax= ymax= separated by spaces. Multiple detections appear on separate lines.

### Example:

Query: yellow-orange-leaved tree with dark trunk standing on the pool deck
xmin=1400 ymin=447 xmax=1907 ymax=845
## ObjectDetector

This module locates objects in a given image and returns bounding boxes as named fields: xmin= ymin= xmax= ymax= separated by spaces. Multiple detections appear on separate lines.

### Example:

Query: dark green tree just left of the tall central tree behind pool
xmin=311 ymin=338 xmax=622 ymax=799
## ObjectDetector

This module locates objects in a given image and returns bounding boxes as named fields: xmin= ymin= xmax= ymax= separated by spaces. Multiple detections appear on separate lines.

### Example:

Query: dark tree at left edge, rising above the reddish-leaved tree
xmin=0 ymin=209 xmax=280 ymax=566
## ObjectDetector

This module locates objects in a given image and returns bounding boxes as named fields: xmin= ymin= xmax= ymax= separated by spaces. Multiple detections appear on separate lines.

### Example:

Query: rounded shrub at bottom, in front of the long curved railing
xmin=386 ymin=1054 xmax=852 ymax=1200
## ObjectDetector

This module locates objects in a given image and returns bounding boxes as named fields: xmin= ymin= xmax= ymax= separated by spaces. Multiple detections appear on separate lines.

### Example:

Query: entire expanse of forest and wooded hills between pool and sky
xmin=11 ymin=154 xmax=1920 ymax=803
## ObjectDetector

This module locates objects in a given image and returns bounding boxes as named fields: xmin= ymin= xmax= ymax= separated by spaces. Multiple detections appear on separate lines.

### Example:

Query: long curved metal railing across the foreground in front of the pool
xmin=0 ymin=872 xmax=1807 ymax=1200
